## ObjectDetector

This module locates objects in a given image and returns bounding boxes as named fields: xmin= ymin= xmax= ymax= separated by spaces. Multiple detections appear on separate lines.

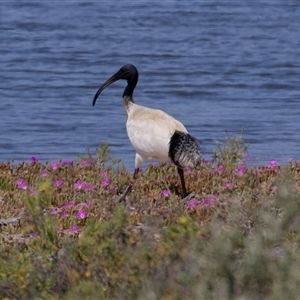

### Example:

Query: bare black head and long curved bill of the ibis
xmin=93 ymin=64 xmax=139 ymax=106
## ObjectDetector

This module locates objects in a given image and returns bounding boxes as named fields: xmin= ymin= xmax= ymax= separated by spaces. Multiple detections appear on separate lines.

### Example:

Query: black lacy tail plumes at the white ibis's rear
xmin=169 ymin=130 xmax=202 ymax=168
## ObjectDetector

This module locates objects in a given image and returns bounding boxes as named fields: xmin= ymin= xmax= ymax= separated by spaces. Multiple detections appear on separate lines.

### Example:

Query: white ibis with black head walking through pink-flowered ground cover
xmin=93 ymin=64 xmax=202 ymax=202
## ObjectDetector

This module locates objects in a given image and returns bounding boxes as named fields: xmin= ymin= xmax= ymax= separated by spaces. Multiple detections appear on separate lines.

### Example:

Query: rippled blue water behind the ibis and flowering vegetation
xmin=0 ymin=0 xmax=300 ymax=170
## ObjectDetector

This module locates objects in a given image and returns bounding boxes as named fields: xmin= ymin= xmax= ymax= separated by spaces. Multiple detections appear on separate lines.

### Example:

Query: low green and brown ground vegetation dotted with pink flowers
xmin=0 ymin=136 xmax=300 ymax=300
